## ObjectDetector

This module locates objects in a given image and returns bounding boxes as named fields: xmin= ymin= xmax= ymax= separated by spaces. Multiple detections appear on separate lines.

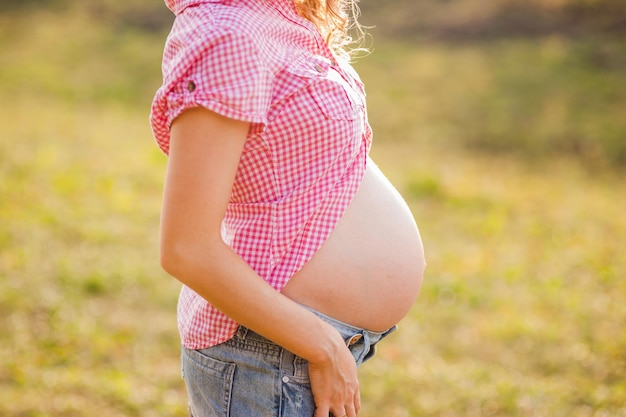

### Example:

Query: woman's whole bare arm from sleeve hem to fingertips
xmin=160 ymin=108 xmax=359 ymax=417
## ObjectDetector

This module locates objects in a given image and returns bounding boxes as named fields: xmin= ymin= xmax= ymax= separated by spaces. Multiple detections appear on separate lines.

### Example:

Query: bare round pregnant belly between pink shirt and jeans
xmin=282 ymin=160 xmax=425 ymax=331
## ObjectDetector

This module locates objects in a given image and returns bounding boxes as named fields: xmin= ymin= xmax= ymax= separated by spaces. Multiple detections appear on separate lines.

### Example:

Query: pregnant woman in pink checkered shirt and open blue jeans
xmin=151 ymin=0 xmax=425 ymax=417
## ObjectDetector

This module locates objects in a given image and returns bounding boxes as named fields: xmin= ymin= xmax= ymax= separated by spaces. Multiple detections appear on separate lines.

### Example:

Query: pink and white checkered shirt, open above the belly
xmin=150 ymin=0 xmax=372 ymax=349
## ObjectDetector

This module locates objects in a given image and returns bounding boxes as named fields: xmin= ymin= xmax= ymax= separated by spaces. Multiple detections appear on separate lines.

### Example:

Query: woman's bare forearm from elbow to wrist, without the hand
xmin=162 ymin=239 xmax=343 ymax=362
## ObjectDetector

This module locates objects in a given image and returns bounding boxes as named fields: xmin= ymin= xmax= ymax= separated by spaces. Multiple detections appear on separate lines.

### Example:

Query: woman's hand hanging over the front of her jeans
xmin=309 ymin=326 xmax=361 ymax=417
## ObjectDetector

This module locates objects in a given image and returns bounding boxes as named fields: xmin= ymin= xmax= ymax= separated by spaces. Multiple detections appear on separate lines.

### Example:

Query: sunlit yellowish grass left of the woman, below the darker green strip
xmin=0 ymin=98 xmax=185 ymax=416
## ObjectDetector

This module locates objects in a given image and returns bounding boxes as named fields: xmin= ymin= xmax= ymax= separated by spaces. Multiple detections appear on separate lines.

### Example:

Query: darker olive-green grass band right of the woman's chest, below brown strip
xmin=359 ymin=36 xmax=626 ymax=167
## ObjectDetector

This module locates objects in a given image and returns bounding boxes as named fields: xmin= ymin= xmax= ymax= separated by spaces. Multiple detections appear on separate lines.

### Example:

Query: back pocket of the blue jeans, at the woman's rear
xmin=182 ymin=349 xmax=237 ymax=417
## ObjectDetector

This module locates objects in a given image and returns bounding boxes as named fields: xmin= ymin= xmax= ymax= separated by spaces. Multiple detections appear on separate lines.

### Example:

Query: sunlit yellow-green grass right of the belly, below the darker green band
xmin=363 ymin=144 xmax=626 ymax=416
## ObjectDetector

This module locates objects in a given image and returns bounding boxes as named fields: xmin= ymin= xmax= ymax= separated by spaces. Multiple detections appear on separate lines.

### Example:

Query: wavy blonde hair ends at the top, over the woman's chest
xmin=295 ymin=0 xmax=364 ymax=58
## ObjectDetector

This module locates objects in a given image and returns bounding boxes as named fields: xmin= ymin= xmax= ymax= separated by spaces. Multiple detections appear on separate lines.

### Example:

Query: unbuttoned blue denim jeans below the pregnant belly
xmin=182 ymin=309 xmax=396 ymax=417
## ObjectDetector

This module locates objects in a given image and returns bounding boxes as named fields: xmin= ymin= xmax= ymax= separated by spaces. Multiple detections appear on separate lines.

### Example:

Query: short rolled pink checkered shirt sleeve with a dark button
xmin=151 ymin=20 xmax=271 ymax=154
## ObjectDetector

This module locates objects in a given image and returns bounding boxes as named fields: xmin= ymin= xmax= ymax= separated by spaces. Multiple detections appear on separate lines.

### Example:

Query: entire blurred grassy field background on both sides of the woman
xmin=0 ymin=0 xmax=626 ymax=417
